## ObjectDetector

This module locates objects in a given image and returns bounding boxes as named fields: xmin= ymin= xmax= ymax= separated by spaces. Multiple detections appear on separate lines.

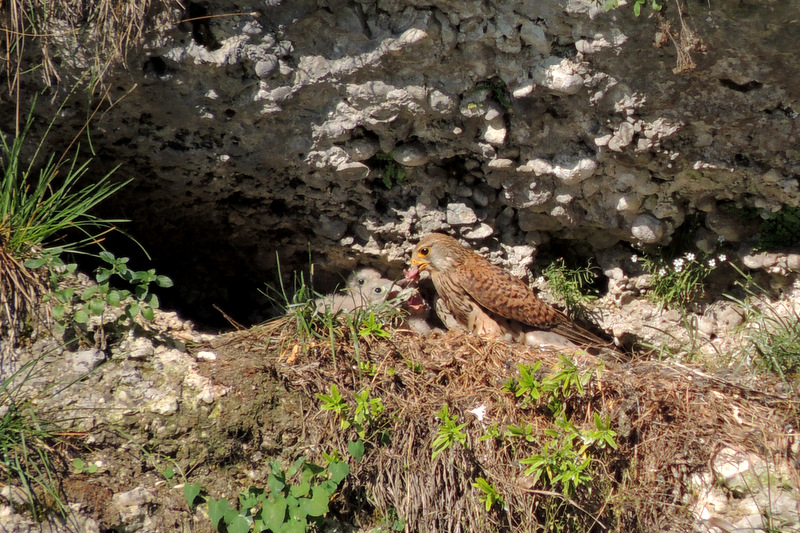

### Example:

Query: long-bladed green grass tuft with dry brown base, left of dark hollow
xmin=0 ymin=95 xmax=128 ymax=349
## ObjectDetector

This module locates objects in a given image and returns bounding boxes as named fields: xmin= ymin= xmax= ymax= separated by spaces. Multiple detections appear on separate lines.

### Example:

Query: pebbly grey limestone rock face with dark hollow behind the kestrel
xmin=7 ymin=0 xmax=800 ymax=324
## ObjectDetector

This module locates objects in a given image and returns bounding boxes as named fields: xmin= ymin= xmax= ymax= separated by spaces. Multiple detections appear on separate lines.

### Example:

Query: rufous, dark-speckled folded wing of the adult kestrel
xmin=451 ymin=254 xmax=568 ymax=328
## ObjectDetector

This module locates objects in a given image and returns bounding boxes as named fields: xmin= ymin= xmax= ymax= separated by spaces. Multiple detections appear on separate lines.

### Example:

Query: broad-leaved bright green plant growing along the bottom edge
xmin=198 ymin=457 xmax=350 ymax=533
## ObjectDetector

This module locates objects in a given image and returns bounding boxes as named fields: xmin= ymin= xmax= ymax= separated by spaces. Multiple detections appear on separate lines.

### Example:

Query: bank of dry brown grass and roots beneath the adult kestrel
xmin=214 ymin=317 xmax=798 ymax=532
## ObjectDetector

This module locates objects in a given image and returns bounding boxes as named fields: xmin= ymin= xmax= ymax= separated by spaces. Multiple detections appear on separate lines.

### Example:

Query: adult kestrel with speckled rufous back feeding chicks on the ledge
xmin=406 ymin=233 xmax=608 ymax=346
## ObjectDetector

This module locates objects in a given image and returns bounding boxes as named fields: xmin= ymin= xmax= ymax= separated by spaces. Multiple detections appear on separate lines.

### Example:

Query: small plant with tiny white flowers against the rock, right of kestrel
xmin=631 ymin=252 xmax=728 ymax=307
